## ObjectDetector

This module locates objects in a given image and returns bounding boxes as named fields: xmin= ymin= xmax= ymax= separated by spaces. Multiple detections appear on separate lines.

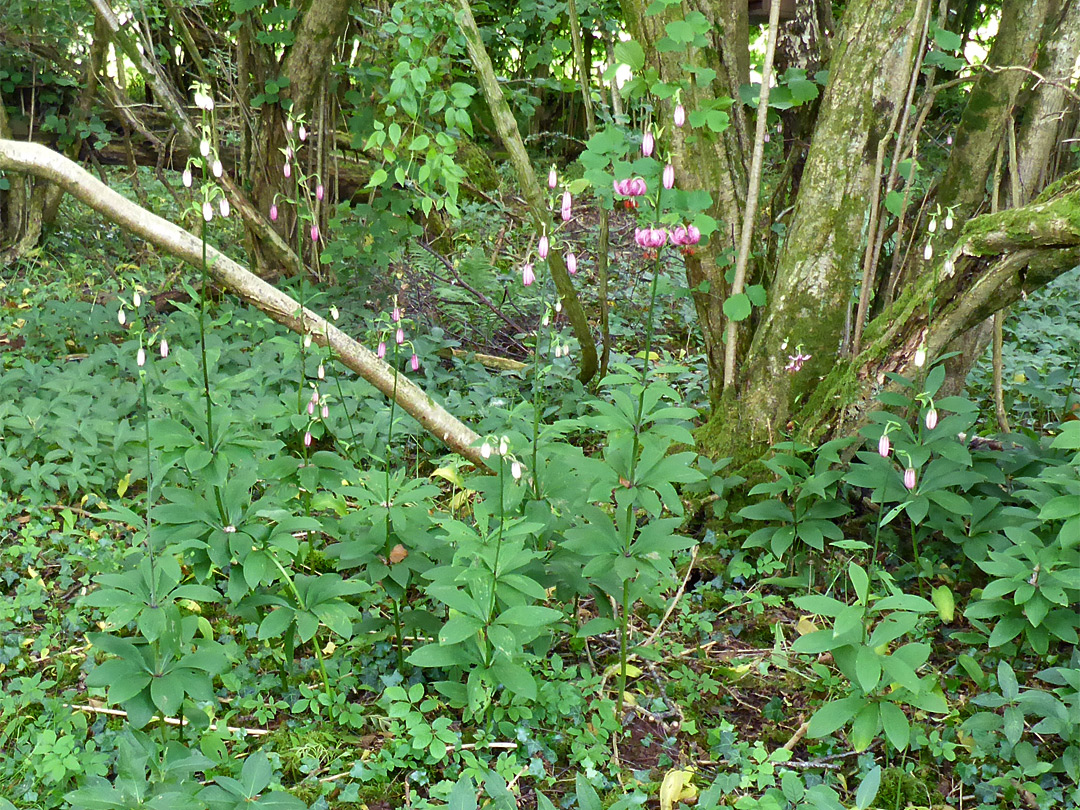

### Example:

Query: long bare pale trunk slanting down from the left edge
xmin=0 ymin=140 xmax=486 ymax=468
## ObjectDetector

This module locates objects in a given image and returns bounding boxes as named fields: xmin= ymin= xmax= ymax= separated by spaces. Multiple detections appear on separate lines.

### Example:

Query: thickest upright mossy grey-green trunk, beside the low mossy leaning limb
xmin=728 ymin=0 xmax=922 ymax=443
